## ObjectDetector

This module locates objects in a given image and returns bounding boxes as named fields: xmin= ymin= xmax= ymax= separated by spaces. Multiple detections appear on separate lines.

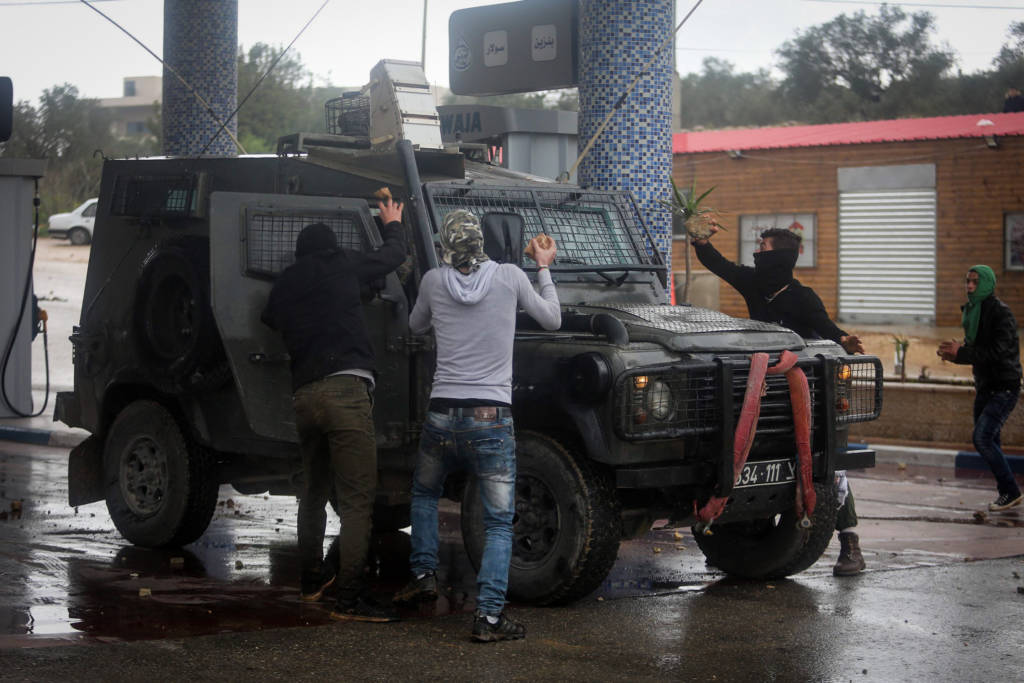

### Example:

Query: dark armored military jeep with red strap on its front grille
xmin=56 ymin=62 xmax=882 ymax=603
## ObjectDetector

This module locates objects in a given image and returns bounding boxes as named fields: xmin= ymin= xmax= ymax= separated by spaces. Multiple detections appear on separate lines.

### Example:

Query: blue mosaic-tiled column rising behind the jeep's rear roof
xmin=163 ymin=0 xmax=239 ymax=156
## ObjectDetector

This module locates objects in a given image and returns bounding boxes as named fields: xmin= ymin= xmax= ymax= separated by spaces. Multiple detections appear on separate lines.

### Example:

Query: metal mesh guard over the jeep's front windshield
xmin=427 ymin=185 xmax=657 ymax=265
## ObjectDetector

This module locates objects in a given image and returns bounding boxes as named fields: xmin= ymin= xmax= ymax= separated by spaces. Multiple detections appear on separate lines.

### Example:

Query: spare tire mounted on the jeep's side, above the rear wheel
xmin=133 ymin=239 xmax=231 ymax=393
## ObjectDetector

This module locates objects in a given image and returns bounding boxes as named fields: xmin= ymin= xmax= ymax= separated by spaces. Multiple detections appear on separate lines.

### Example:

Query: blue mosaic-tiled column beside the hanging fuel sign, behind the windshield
xmin=579 ymin=0 xmax=674 ymax=278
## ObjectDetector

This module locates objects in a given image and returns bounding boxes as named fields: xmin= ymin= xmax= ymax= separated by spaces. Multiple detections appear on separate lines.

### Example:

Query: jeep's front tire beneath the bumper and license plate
xmin=693 ymin=483 xmax=838 ymax=580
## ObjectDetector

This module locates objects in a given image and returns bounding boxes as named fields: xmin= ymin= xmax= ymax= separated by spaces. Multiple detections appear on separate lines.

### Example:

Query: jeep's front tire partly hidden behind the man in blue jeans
xmin=462 ymin=432 xmax=622 ymax=604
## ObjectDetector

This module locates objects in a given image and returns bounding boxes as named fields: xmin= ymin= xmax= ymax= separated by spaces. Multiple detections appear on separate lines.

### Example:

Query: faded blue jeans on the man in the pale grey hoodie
xmin=410 ymin=413 xmax=515 ymax=615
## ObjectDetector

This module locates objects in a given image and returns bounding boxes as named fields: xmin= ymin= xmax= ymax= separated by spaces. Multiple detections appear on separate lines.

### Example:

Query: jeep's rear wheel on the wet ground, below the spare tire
xmin=103 ymin=400 xmax=219 ymax=548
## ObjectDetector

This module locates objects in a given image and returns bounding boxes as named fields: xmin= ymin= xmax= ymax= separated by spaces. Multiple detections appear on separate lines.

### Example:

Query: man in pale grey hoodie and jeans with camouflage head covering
xmin=394 ymin=210 xmax=561 ymax=642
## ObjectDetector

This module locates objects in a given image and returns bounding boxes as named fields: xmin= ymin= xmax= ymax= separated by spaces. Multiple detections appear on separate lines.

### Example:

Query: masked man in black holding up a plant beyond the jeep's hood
xmin=693 ymin=224 xmax=865 ymax=577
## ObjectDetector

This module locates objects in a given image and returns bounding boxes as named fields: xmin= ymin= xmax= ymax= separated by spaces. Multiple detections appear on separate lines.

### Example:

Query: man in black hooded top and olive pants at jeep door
xmin=262 ymin=199 xmax=406 ymax=622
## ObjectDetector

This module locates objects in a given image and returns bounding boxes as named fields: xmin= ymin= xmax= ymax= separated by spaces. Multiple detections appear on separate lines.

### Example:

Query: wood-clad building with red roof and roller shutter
xmin=672 ymin=113 xmax=1024 ymax=329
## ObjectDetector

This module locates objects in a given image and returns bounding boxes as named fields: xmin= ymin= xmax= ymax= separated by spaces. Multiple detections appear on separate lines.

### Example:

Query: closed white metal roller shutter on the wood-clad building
xmin=839 ymin=189 xmax=935 ymax=325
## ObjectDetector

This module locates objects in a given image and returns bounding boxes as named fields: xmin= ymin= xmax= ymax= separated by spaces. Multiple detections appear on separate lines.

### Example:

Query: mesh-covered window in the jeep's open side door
xmin=246 ymin=212 xmax=367 ymax=278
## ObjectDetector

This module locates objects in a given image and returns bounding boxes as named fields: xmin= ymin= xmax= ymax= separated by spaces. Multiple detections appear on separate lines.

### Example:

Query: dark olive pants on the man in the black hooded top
xmin=293 ymin=375 xmax=377 ymax=598
